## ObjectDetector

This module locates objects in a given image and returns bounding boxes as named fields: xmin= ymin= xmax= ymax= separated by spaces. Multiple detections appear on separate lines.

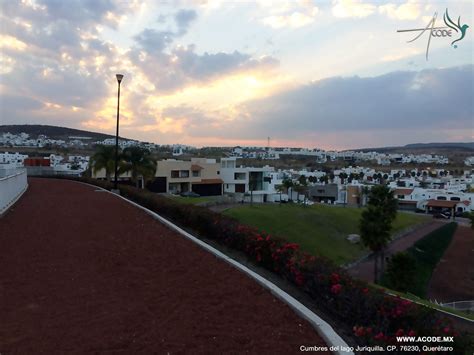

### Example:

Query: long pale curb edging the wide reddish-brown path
xmin=86 ymin=182 xmax=354 ymax=355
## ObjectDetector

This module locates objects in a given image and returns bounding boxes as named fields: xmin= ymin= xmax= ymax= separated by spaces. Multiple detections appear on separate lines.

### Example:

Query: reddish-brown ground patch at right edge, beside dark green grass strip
xmin=428 ymin=226 xmax=474 ymax=302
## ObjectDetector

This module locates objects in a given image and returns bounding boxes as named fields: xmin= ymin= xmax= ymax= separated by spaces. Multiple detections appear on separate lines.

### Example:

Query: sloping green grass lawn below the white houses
xmin=223 ymin=204 xmax=427 ymax=265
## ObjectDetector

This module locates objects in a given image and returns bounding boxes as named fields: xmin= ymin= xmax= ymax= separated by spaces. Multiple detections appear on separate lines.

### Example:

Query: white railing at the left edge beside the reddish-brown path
xmin=0 ymin=169 xmax=28 ymax=216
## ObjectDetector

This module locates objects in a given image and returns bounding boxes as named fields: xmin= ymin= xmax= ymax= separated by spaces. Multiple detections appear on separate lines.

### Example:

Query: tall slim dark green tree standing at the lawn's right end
xmin=359 ymin=185 xmax=397 ymax=282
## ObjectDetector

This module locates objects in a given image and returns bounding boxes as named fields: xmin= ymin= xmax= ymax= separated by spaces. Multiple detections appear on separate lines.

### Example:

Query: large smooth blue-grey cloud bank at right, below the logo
xmin=239 ymin=66 xmax=474 ymax=134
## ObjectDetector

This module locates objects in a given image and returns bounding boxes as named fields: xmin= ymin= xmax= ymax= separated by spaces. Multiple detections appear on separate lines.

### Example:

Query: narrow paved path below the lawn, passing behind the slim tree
xmin=347 ymin=221 xmax=443 ymax=282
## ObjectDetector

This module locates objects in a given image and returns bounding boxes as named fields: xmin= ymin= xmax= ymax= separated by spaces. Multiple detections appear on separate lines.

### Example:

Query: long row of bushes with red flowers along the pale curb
xmin=75 ymin=178 xmax=472 ymax=351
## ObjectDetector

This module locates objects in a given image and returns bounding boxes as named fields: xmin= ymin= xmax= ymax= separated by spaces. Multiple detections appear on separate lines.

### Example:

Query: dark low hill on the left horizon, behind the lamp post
xmin=0 ymin=125 xmax=120 ymax=141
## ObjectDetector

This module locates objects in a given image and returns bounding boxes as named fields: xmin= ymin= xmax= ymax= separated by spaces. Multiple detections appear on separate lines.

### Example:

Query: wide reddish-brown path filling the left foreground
xmin=0 ymin=179 xmax=324 ymax=354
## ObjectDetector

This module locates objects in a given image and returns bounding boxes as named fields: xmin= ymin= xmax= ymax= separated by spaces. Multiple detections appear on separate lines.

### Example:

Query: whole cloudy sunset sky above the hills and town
xmin=0 ymin=0 xmax=474 ymax=149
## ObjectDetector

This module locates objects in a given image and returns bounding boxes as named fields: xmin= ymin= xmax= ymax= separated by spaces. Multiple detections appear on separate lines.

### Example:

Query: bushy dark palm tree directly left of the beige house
xmin=119 ymin=147 xmax=156 ymax=188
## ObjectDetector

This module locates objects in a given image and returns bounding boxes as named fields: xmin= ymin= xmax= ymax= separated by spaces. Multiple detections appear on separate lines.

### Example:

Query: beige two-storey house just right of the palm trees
xmin=149 ymin=158 xmax=223 ymax=196
